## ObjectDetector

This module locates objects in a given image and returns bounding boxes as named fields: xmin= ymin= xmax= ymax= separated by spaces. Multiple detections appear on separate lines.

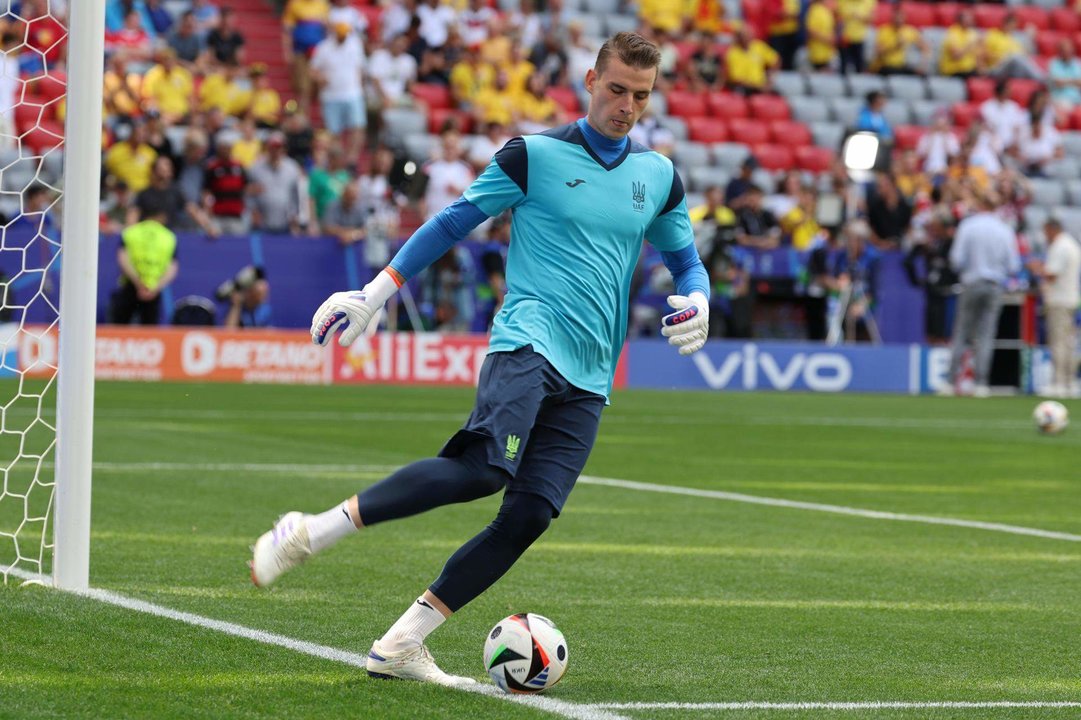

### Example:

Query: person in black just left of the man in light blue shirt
xmin=905 ymin=208 xmax=958 ymax=345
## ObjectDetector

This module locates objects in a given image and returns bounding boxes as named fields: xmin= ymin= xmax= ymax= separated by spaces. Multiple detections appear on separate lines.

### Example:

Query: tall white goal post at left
xmin=53 ymin=0 xmax=106 ymax=590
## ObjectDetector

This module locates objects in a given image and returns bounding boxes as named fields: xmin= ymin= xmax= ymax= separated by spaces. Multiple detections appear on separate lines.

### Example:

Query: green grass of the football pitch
xmin=0 ymin=383 xmax=1081 ymax=720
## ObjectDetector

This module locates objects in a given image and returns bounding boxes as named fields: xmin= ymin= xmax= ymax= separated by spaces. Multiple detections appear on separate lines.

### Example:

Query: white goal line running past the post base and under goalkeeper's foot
xmin=0 ymin=565 xmax=630 ymax=720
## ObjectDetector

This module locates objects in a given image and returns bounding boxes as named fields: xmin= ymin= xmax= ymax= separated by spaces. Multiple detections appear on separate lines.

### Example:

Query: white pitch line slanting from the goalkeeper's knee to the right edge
xmin=578 ymin=475 xmax=1081 ymax=543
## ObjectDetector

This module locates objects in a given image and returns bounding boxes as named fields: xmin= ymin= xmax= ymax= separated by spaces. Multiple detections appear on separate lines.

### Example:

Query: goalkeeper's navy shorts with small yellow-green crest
xmin=439 ymin=345 xmax=604 ymax=517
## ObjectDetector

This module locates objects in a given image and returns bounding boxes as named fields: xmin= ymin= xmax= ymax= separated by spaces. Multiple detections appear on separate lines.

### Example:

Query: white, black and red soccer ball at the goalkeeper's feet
xmin=484 ymin=613 xmax=566 ymax=693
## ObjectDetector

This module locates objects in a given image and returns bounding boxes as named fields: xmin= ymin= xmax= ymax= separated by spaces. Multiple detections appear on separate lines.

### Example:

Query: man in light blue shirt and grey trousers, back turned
xmin=940 ymin=191 xmax=1020 ymax=398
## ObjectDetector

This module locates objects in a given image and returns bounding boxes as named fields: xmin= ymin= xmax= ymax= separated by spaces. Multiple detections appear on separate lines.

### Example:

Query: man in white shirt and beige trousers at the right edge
xmin=1037 ymin=217 xmax=1081 ymax=398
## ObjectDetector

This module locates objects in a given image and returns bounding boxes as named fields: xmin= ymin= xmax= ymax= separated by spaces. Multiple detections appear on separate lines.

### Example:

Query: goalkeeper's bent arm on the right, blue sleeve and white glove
xmin=645 ymin=169 xmax=709 ymax=355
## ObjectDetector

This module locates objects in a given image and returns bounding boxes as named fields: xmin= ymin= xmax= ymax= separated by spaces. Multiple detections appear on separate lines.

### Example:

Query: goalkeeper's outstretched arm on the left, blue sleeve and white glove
xmin=311 ymin=137 xmax=526 ymax=347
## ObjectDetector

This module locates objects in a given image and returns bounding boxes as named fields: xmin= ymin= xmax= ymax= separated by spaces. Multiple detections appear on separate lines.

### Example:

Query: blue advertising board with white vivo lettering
xmin=627 ymin=341 xmax=921 ymax=392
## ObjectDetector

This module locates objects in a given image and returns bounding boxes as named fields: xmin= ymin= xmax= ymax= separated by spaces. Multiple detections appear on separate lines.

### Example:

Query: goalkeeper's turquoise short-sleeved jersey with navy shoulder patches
xmin=464 ymin=123 xmax=694 ymax=397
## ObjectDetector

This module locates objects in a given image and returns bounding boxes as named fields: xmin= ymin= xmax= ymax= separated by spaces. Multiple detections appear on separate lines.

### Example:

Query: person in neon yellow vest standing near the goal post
xmin=106 ymin=204 xmax=179 ymax=325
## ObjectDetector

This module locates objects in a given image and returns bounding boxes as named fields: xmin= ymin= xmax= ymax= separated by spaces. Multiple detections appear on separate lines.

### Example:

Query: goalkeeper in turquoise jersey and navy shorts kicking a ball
xmin=252 ymin=32 xmax=709 ymax=684
